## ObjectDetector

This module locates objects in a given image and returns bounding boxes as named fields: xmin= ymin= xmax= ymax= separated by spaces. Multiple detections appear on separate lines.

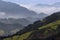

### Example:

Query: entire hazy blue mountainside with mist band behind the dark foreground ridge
xmin=0 ymin=0 xmax=48 ymax=35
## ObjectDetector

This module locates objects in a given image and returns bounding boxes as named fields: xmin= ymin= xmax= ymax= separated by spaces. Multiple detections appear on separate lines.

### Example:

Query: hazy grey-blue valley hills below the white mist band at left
xmin=0 ymin=18 xmax=32 ymax=36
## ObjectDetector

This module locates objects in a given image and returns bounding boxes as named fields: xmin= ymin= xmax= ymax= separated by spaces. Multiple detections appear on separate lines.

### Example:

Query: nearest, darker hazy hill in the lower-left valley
xmin=0 ymin=22 xmax=23 ymax=36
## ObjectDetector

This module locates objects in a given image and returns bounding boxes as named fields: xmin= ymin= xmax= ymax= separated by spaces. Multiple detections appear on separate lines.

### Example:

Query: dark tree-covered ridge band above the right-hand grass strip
xmin=15 ymin=12 xmax=60 ymax=34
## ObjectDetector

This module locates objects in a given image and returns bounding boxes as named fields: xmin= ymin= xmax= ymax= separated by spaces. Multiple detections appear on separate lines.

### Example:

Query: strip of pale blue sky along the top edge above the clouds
xmin=2 ymin=0 xmax=60 ymax=4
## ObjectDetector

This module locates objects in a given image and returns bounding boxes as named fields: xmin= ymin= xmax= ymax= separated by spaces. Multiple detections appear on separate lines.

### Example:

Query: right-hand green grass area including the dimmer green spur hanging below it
xmin=38 ymin=20 xmax=60 ymax=35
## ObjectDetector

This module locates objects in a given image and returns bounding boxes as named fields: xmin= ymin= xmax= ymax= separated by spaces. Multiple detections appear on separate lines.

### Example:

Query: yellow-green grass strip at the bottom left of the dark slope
xmin=4 ymin=31 xmax=32 ymax=40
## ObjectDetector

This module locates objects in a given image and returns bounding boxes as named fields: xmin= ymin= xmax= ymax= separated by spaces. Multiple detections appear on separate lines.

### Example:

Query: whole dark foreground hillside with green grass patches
xmin=0 ymin=12 xmax=60 ymax=40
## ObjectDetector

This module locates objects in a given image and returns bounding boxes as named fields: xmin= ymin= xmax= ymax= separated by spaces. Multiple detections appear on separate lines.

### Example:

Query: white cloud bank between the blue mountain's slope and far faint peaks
xmin=20 ymin=4 xmax=60 ymax=14
